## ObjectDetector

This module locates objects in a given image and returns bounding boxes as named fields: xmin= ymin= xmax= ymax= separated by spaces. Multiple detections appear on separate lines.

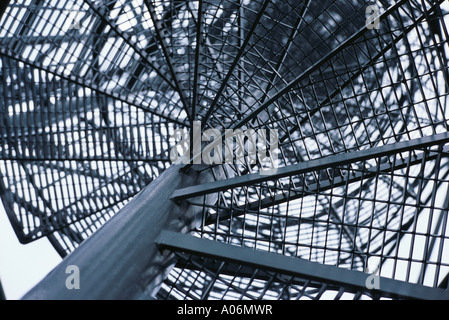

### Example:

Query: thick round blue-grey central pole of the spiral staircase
xmin=23 ymin=165 xmax=224 ymax=300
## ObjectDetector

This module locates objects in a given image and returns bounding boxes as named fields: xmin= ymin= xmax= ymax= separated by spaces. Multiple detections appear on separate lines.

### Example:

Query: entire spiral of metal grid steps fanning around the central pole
xmin=0 ymin=0 xmax=449 ymax=299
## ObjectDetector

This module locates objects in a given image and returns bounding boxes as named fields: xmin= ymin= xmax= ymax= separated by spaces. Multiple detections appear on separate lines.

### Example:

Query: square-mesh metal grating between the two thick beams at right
xmin=180 ymin=139 xmax=449 ymax=287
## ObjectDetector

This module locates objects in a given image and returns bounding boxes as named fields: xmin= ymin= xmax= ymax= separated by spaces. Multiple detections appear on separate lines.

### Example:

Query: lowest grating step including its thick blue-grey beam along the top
xmin=156 ymin=231 xmax=449 ymax=300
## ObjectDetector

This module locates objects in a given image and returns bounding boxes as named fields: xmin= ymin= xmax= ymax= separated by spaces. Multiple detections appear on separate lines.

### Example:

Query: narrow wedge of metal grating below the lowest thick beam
xmin=157 ymin=253 xmax=389 ymax=300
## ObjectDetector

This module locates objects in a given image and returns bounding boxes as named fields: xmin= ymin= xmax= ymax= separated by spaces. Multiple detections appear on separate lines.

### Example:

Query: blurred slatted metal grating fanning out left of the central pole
xmin=0 ymin=0 xmax=186 ymax=255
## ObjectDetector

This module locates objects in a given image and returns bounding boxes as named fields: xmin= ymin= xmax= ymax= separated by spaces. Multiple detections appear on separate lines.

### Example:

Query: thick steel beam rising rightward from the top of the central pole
xmin=171 ymin=132 xmax=449 ymax=200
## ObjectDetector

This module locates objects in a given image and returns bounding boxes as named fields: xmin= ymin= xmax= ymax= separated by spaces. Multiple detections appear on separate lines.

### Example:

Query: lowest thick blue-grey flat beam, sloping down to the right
xmin=156 ymin=230 xmax=449 ymax=300
